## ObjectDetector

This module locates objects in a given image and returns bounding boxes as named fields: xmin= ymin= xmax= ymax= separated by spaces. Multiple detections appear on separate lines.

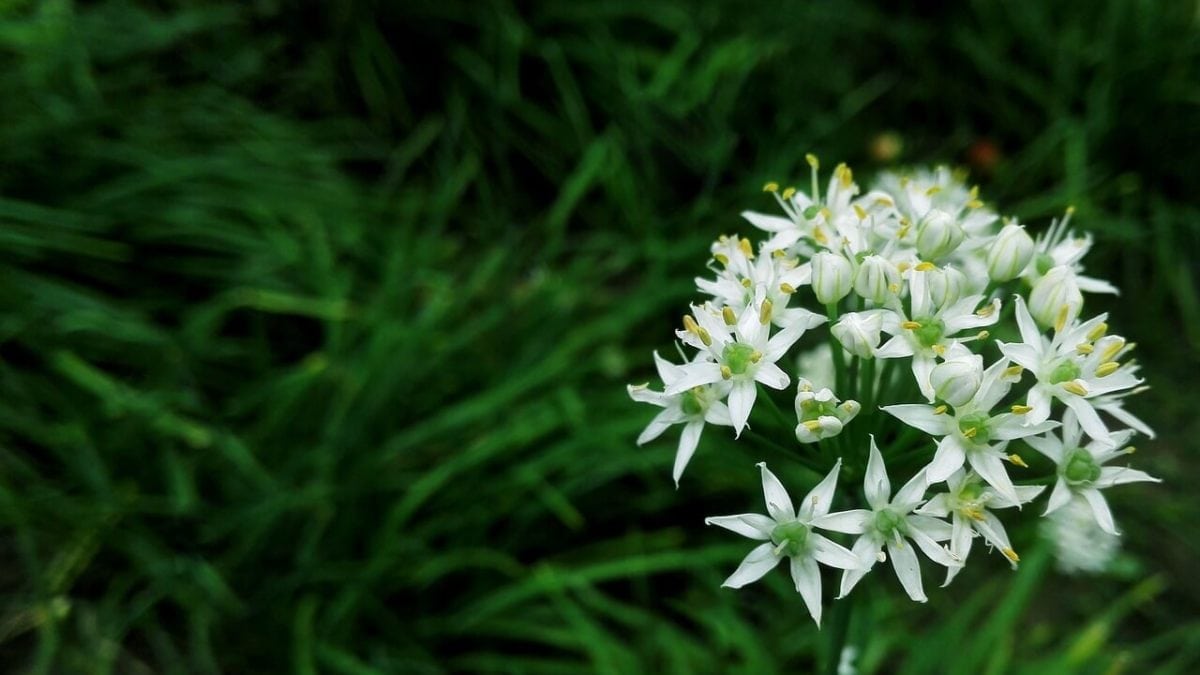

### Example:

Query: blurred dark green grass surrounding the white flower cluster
xmin=0 ymin=0 xmax=1200 ymax=674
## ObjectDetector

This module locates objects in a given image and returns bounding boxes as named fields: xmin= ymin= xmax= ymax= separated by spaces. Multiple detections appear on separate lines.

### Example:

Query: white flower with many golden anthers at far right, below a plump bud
xmin=1000 ymin=295 xmax=1141 ymax=440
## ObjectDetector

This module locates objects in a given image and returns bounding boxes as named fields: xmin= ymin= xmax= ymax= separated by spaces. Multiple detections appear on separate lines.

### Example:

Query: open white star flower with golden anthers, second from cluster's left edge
xmin=666 ymin=303 xmax=824 ymax=436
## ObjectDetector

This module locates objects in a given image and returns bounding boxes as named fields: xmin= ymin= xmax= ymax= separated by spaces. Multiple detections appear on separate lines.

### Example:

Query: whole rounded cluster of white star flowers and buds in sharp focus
xmin=629 ymin=155 xmax=1156 ymax=623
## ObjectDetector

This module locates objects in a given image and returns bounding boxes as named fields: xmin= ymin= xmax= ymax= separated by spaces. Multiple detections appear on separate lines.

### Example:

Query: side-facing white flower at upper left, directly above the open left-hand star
xmin=696 ymin=237 xmax=824 ymax=328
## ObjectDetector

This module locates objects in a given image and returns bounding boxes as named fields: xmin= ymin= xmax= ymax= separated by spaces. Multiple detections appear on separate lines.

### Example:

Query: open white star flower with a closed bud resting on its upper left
xmin=881 ymin=359 xmax=1058 ymax=502
